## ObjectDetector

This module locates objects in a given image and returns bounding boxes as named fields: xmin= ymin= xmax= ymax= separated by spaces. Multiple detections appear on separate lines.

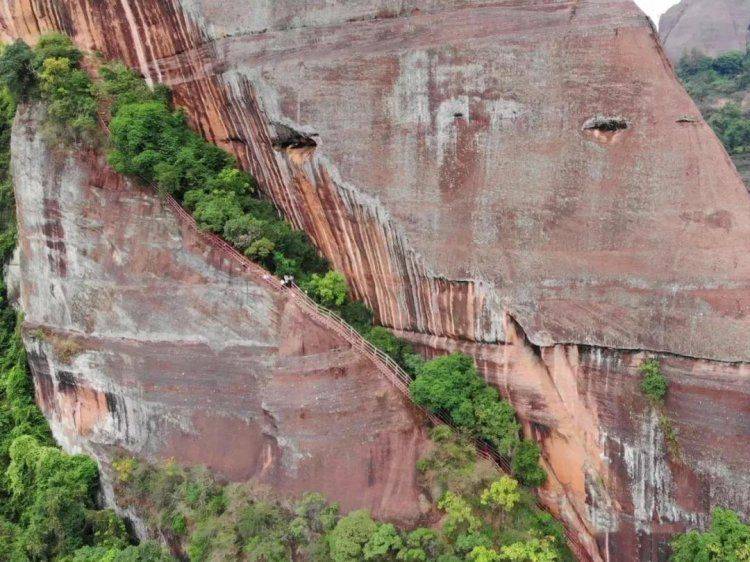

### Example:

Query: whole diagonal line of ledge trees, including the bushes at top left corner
xmin=0 ymin=31 xmax=546 ymax=486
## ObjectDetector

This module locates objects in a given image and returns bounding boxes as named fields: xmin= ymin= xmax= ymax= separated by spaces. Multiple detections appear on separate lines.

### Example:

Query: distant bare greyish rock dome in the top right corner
xmin=659 ymin=0 xmax=750 ymax=62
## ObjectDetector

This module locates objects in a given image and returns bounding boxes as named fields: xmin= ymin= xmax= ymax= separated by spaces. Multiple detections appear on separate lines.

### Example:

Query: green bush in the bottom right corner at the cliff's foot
xmin=670 ymin=508 xmax=750 ymax=562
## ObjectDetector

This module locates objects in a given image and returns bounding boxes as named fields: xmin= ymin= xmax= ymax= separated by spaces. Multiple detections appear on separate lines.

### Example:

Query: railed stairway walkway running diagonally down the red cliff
xmin=166 ymin=195 xmax=594 ymax=562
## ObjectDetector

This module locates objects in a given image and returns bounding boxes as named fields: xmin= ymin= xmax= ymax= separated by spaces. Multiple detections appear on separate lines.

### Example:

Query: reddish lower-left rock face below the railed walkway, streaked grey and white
xmin=12 ymin=105 xmax=425 ymax=523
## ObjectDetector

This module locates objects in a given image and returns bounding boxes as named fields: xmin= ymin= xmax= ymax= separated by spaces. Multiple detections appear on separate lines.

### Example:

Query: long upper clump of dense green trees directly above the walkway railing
xmin=99 ymin=64 xmax=334 ymax=284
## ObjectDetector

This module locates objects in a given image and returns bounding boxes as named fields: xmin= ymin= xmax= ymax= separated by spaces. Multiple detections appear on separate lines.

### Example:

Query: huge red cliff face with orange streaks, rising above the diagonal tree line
xmin=0 ymin=0 xmax=750 ymax=561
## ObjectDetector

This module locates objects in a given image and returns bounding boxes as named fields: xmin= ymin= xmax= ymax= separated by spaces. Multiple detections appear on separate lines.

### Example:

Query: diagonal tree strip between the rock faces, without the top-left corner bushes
xmin=91 ymin=40 xmax=546 ymax=485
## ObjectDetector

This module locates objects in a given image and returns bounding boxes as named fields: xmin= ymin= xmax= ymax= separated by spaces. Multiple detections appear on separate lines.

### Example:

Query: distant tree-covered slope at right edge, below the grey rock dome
xmin=677 ymin=50 xmax=750 ymax=185
